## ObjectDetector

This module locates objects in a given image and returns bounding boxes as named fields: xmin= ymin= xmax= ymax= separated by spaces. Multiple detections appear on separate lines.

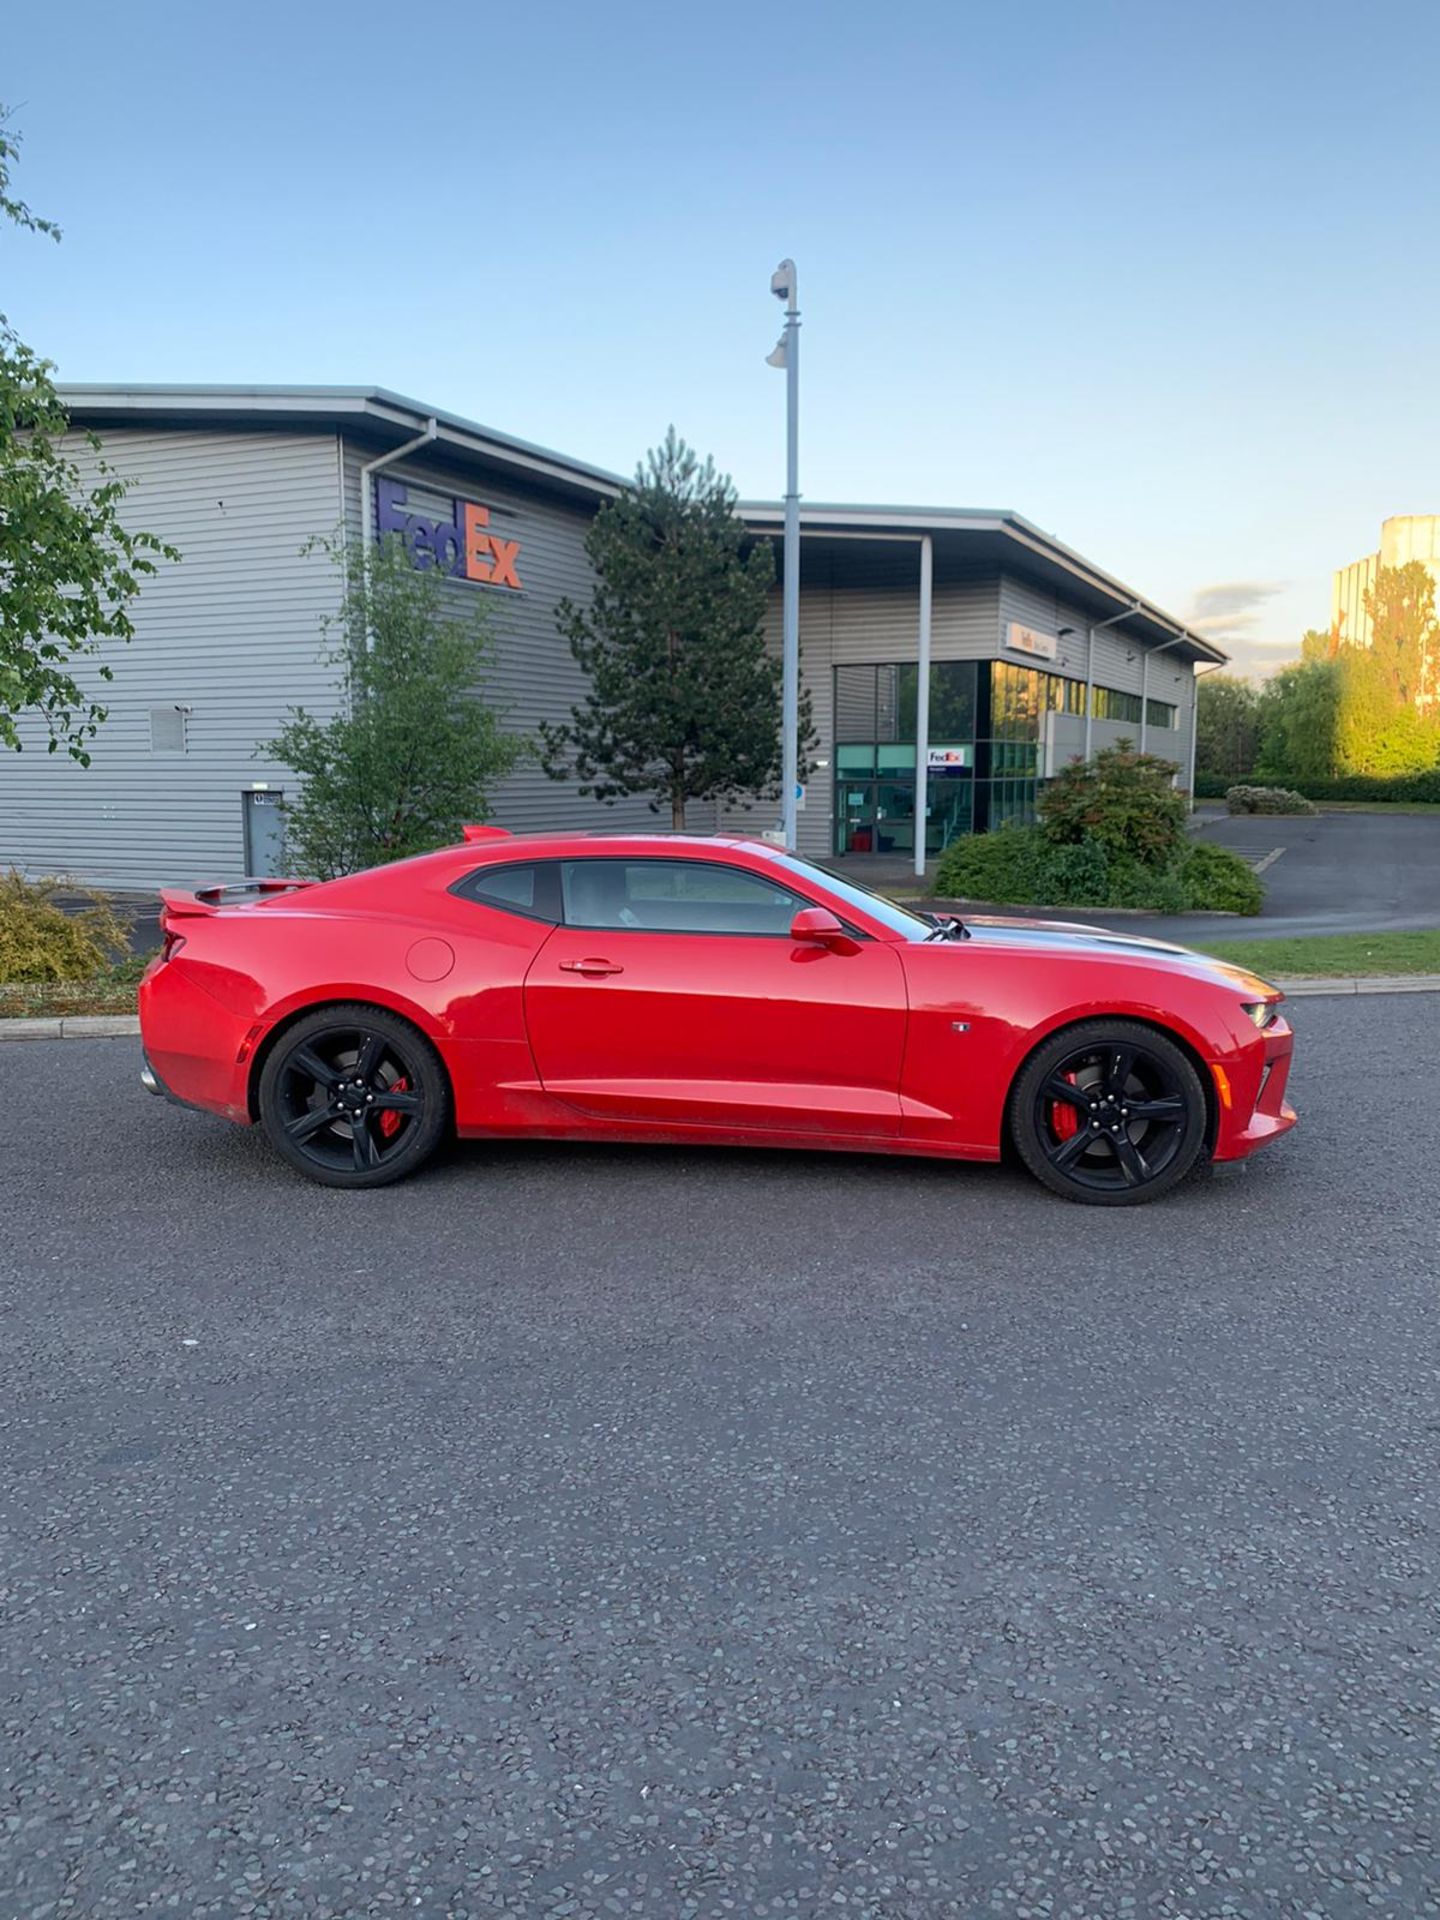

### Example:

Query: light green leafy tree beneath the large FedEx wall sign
xmin=259 ymin=536 xmax=528 ymax=879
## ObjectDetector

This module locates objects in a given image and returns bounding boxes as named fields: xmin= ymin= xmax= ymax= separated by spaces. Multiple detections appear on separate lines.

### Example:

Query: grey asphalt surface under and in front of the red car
xmin=0 ymin=995 xmax=1440 ymax=1920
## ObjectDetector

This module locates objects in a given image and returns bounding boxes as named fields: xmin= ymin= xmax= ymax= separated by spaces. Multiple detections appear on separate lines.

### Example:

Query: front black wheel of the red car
xmin=1010 ymin=1020 xmax=1208 ymax=1206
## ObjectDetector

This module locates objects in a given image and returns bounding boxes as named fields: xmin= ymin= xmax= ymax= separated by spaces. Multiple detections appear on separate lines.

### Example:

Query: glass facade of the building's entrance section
xmin=835 ymin=660 xmax=1179 ymax=854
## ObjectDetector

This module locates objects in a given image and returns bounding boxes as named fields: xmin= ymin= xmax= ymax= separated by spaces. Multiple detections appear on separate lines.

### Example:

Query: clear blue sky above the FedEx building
xmin=0 ymin=0 xmax=1440 ymax=668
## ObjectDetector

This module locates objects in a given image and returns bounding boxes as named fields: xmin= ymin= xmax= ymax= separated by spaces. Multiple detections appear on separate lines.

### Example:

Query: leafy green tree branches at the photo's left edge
xmin=0 ymin=108 xmax=179 ymax=766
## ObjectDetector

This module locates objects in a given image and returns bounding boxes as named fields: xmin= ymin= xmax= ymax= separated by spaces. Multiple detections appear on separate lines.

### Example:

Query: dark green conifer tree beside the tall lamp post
xmin=541 ymin=426 xmax=812 ymax=828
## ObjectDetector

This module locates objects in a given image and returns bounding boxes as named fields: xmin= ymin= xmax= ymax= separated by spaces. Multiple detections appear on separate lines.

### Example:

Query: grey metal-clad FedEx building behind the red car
xmin=0 ymin=386 xmax=1225 ymax=891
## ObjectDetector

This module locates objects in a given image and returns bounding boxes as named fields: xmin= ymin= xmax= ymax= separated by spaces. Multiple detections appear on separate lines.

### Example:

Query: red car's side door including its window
xmin=524 ymin=854 xmax=906 ymax=1137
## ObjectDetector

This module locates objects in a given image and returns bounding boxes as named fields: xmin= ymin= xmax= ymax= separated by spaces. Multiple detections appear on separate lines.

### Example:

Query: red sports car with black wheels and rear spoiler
xmin=140 ymin=828 xmax=1294 ymax=1206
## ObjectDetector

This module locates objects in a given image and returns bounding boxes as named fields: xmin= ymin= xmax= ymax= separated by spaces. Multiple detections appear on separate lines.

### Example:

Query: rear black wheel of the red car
xmin=257 ymin=1004 xmax=449 ymax=1187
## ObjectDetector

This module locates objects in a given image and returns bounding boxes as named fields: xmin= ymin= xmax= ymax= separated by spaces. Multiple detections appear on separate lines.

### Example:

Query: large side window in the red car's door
xmin=561 ymin=858 xmax=810 ymax=939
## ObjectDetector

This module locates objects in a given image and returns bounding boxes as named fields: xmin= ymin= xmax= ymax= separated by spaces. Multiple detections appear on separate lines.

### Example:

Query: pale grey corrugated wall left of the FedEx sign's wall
xmin=0 ymin=428 xmax=340 ymax=889
